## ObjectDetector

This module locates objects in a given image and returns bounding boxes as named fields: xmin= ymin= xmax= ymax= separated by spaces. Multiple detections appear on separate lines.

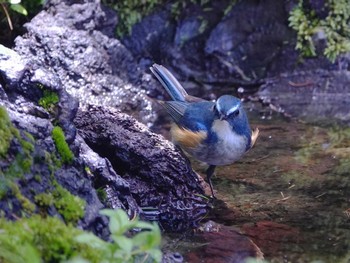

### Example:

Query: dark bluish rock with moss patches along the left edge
xmin=0 ymin=44 xmax=107 ymax=236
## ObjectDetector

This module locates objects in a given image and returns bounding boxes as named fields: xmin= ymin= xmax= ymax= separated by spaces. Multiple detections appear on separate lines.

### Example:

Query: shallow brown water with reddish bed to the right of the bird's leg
xmin=161 ymin=102 xmax=350 ymax=263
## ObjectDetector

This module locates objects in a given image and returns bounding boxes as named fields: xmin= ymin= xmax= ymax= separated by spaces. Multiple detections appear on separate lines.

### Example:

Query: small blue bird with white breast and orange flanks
xmin=150 ymin=64 xmax=259 ymax=199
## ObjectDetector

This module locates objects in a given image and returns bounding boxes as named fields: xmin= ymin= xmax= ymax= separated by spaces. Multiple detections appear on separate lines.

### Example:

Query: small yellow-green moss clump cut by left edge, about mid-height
xmin=0 ymin=107 xmax=13 ymax=157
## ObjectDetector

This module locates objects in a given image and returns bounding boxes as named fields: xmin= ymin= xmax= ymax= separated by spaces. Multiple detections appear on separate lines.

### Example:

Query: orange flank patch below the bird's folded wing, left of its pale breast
xmin=171 ymin=124 xmax=207 ymax=149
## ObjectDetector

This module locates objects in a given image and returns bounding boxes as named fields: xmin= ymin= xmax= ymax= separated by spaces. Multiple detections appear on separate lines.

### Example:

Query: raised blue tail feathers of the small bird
xmin=150 ymin=64 xmax=188 ymax=102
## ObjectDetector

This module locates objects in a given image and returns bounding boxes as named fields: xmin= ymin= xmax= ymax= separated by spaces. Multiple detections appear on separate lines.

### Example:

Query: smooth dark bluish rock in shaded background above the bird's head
xmin=205 ymin=0 xmax=293 ymax=82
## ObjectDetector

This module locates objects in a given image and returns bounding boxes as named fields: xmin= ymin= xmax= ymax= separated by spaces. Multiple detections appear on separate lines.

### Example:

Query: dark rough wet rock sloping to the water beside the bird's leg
xmin=75 ymin=106 xmax=208 ymax=231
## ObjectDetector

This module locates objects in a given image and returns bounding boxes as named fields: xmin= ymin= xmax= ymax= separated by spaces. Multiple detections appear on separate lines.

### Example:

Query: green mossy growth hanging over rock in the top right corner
xmin=289 ymin=0 xmax=350 ymax=62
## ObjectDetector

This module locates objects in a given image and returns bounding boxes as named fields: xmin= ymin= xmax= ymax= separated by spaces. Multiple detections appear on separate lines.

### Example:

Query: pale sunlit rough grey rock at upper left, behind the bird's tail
xmin=15 ymin=1 xmax=157 ymax=126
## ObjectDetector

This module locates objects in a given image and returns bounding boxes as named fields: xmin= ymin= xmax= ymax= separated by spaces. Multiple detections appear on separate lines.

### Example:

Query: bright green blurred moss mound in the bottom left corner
xmin=0 ymin=215 xmax=103 ymax=263
